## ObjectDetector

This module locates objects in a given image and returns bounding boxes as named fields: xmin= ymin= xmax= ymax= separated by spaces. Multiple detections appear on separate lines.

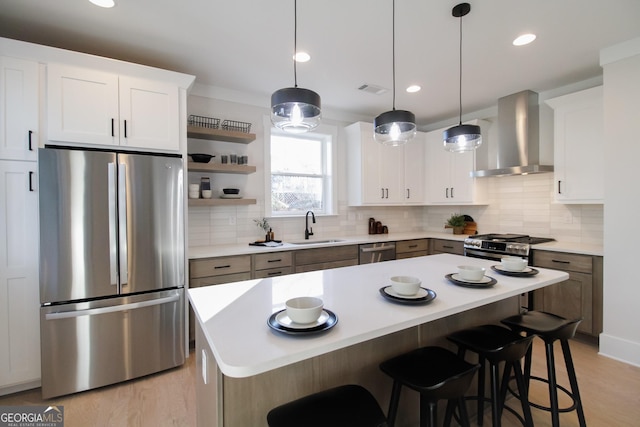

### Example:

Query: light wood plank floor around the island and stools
xmin=0 ymin=339 xmax=640 ymax=427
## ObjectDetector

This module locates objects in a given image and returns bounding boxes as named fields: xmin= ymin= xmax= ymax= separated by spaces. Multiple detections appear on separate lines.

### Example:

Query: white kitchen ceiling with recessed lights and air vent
xmin=0 ymin=0 xmax=640 ymax=126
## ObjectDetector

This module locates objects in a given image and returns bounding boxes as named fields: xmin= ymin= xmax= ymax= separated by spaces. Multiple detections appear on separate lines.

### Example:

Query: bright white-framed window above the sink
xmin=266 ymin=120 xmax=336 ymax=217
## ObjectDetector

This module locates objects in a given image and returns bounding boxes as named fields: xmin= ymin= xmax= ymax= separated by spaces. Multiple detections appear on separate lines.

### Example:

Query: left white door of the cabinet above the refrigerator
xmin=47 ymin=64 xmax=119 ymax=145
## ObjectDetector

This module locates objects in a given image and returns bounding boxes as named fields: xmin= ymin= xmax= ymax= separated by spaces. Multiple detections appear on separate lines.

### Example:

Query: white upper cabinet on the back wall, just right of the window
xmin=345 ymin=122 xmax=424 ymax=206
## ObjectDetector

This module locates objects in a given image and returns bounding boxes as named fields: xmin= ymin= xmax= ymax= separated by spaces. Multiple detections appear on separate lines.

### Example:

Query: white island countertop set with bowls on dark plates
xmin=188 ymin=254 xmax=569 ymax=378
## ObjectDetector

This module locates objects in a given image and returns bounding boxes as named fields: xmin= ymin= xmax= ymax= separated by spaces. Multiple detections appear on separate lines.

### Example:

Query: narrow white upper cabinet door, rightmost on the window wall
xmin=403 ymin=132 xmax=427 ymax=204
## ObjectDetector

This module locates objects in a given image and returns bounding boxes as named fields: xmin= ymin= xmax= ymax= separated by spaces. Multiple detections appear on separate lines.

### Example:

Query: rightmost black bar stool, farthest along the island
xmin=502 ymin=311 xmax=587 ymax=427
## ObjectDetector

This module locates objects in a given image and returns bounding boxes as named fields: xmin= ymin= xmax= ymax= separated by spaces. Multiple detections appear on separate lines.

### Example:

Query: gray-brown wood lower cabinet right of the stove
xmin=533 ymin=250 xmax=603 ymax=336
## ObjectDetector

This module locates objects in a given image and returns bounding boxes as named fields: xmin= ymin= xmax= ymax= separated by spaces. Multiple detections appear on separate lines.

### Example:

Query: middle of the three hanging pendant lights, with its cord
xmin=373 ymin=0 xmax=416 ymax=146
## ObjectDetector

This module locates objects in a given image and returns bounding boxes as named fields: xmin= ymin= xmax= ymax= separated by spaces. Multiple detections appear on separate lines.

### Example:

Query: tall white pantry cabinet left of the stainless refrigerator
xmin=0 ymin=56 xmax=40 ymax=394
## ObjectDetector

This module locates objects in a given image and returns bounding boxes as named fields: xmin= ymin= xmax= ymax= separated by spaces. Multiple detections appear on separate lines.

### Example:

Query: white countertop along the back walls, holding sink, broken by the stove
xmin=189 ymin=231 xmax=603 ymax=259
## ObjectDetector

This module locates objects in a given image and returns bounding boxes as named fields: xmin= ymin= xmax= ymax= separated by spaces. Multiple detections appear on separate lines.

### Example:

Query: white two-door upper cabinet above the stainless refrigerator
xmin=47 ymin=64 xmax=180 ymax=151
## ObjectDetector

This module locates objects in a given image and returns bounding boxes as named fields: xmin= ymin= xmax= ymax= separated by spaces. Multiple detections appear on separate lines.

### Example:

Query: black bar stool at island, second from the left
xmin=380 ymin=347 xmax=480 ymax=427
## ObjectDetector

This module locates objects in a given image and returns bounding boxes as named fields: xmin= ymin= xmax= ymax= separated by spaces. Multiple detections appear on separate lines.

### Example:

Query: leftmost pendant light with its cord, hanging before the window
xmin=271 ymin=0 xmax=321 ymax=133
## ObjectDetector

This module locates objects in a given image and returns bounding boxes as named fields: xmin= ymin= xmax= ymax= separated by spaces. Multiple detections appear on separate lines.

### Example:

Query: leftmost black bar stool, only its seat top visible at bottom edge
xmin=267 ymin=384 xmax=387 ymax=427
